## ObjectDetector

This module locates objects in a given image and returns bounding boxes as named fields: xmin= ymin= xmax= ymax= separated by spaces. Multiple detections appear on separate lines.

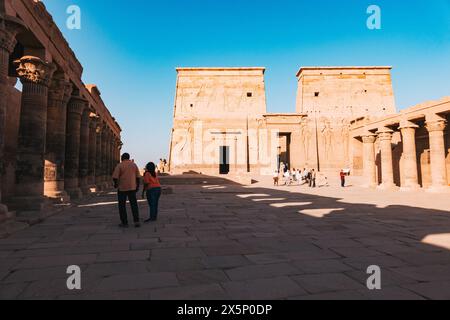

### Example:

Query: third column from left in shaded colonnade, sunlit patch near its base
xmin=44 ymin=74 xmax=72 ymax=202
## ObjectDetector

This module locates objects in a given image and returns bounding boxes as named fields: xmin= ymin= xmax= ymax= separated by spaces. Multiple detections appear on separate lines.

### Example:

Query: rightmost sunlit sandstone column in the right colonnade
xmin=426 ymin=115 xmax=450 ymax=192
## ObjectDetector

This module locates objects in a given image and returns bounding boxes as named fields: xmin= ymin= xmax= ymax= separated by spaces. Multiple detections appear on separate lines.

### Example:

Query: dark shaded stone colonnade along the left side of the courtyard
xmin=0 ymin=0 xmax=121 ymax=219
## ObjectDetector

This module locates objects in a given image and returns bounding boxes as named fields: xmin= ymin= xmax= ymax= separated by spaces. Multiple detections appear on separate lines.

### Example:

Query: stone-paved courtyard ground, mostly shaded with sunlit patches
xmin=0 ymin=177 xmax=450 ymax=299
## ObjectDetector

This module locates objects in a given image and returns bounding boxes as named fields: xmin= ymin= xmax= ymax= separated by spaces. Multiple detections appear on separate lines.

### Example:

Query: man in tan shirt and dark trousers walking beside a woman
xmin=112 ymin=153 xmax=141 ymax=228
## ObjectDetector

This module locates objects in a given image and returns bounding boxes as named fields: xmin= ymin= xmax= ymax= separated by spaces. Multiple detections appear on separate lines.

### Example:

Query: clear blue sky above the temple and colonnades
xmin=44 ymin=0 xmax=450 ymax=165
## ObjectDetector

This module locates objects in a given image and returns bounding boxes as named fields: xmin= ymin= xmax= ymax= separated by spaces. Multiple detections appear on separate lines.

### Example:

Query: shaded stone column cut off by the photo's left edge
xmin=0 ymin=13 xmax=23 ymax=215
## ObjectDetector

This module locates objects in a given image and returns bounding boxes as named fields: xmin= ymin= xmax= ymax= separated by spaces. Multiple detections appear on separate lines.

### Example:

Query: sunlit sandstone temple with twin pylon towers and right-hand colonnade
xmin=169 ymin=66 xmax=450 ymax=191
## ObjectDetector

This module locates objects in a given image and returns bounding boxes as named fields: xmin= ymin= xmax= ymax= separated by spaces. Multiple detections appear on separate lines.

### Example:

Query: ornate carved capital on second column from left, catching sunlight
xmin=14 ymin=56 xmax=56 ymax=87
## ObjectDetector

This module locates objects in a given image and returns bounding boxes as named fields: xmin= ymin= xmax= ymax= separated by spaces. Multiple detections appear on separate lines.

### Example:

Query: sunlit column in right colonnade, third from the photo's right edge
xmin=378 ymin=128 xmax=396 ymax=189
